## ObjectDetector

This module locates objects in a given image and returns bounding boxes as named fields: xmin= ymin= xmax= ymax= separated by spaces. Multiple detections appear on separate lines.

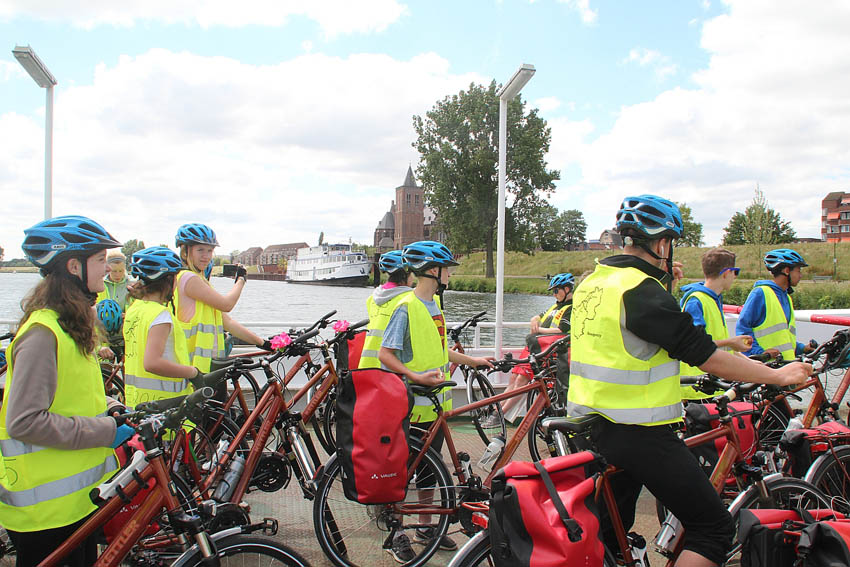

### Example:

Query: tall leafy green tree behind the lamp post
xmin=413 ymin=81 xmax=560 ymax=277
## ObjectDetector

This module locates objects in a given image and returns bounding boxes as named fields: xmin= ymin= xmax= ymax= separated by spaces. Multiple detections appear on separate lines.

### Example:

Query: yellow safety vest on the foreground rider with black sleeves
xmin=567 ymin=264 xmax=682 ymax=425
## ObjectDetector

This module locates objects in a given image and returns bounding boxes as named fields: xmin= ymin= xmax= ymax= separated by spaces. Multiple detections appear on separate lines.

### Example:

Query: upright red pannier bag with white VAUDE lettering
xmin=336 ymin=368 xmax=413 ymax=504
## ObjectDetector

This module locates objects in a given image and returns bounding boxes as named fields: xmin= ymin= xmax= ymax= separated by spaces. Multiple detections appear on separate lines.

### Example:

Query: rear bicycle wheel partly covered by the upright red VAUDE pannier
xmin=313 ymin=442 xmax=455 ymax=567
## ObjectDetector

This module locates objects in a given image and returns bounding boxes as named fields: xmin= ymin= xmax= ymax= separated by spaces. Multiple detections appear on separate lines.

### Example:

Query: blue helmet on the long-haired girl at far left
xmin=21 ymin=215 xmax=121 ymax=275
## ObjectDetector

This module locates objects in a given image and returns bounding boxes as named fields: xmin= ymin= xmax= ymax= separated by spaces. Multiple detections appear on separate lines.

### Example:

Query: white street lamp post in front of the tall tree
xmin=495 ymin=64 xmax=535 ymax=358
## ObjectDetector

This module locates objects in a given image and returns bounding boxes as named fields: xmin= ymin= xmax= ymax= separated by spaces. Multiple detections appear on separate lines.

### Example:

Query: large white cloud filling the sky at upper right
xmin=549 ymin=0 xmax=850 ymax=244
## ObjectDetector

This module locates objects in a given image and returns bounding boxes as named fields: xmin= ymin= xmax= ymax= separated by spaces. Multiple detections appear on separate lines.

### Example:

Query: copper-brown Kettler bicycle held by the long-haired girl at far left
xmin=30 ymin=388 xmax=307 ymax=567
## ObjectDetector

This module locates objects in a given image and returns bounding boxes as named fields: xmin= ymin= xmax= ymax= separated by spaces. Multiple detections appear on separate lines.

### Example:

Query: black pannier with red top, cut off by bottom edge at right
xmin=738 ymin=508 xmax=848 ymax=567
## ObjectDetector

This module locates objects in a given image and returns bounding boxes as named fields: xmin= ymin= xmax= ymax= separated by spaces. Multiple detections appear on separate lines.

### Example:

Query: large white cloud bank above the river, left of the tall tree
xmin=0 ymin=49 xmax=486 ymax=253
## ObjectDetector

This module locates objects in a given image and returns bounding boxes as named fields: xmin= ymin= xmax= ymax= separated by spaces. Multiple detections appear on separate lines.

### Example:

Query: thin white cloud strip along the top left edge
xmin=0 ymin=0 xmax=407 ymax=37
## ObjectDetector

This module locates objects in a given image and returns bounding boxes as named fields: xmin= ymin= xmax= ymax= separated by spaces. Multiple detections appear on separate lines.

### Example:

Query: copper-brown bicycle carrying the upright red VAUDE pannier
xmin=313 ymin=338 xmax=568 ymax=567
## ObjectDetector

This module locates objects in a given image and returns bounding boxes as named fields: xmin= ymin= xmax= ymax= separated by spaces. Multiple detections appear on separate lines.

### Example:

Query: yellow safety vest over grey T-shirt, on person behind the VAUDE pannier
xmin=396 ymin=292 xmax=452 ymax=423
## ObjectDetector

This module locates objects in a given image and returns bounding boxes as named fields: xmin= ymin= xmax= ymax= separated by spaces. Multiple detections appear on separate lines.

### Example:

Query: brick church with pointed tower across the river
xmin=373 ymin=166 xmax=446 ymax=253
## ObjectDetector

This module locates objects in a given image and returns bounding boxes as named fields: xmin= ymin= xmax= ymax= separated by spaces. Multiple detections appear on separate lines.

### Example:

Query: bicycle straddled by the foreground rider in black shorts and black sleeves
xmin=449 ymin=379 xmax=828 ymax=567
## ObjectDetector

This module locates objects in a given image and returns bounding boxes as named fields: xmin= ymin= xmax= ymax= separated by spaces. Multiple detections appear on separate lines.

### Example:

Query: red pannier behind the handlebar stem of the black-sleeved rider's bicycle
xmin=685 ymin=402 xmax=760 ymax=482
